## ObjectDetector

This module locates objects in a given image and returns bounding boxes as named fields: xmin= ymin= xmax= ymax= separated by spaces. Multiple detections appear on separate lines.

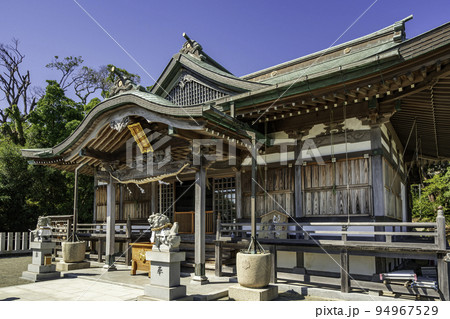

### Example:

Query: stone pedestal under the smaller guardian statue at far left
xmin=22 ymin=241 xmax=60 ymax=281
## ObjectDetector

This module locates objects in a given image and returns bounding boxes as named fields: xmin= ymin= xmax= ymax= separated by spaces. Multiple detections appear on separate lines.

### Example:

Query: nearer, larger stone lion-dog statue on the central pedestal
xmin=148 ymin=213 xmax=181 ymax=251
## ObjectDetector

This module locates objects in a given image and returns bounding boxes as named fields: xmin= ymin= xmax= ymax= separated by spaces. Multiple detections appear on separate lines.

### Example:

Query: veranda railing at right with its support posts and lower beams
xmin=215 ymin=207 xmax=450 ymax=300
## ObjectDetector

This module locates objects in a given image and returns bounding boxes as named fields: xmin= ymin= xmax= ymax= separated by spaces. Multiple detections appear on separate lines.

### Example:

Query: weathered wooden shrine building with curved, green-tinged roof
xmin=22 ymin=17 xmax=450 ymax=300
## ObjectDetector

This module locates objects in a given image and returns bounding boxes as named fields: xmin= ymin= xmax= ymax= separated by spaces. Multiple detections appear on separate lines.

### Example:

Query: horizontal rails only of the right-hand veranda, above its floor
xmin=216 ymin=215 xmax=447 ymax=250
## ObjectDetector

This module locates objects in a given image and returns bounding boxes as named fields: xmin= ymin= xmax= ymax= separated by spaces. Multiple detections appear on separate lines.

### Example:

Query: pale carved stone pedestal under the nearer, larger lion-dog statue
xmin=144 ymin=251 xmax=186 ymax=300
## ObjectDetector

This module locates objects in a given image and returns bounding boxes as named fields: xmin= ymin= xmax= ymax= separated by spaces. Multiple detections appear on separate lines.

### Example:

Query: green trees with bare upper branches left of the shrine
xmin=0 ymin=40 xmax=146 ymax=232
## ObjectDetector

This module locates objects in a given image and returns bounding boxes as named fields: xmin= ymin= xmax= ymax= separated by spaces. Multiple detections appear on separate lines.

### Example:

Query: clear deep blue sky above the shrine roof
xmin=0 ymin=0 xmax=450 ymax=96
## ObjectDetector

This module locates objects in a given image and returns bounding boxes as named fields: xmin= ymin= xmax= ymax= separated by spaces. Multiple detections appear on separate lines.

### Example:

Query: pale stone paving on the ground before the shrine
xmin=0 ymin=260 xmax=400 ymax=301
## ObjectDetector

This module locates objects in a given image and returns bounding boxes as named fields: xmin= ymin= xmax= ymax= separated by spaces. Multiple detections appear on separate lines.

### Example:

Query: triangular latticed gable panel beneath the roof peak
xmin=165 ymin=71 xmax=231 ymax=105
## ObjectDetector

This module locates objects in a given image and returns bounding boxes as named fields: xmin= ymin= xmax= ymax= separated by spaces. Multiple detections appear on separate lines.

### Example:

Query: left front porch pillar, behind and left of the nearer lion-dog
xmin=103 ymin=177 xmax=116 ymax=270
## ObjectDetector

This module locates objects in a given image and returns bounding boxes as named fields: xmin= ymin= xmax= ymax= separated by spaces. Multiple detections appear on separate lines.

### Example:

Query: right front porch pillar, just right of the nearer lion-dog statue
xmin=192 ymin=157 xmax=208 ymax=284
